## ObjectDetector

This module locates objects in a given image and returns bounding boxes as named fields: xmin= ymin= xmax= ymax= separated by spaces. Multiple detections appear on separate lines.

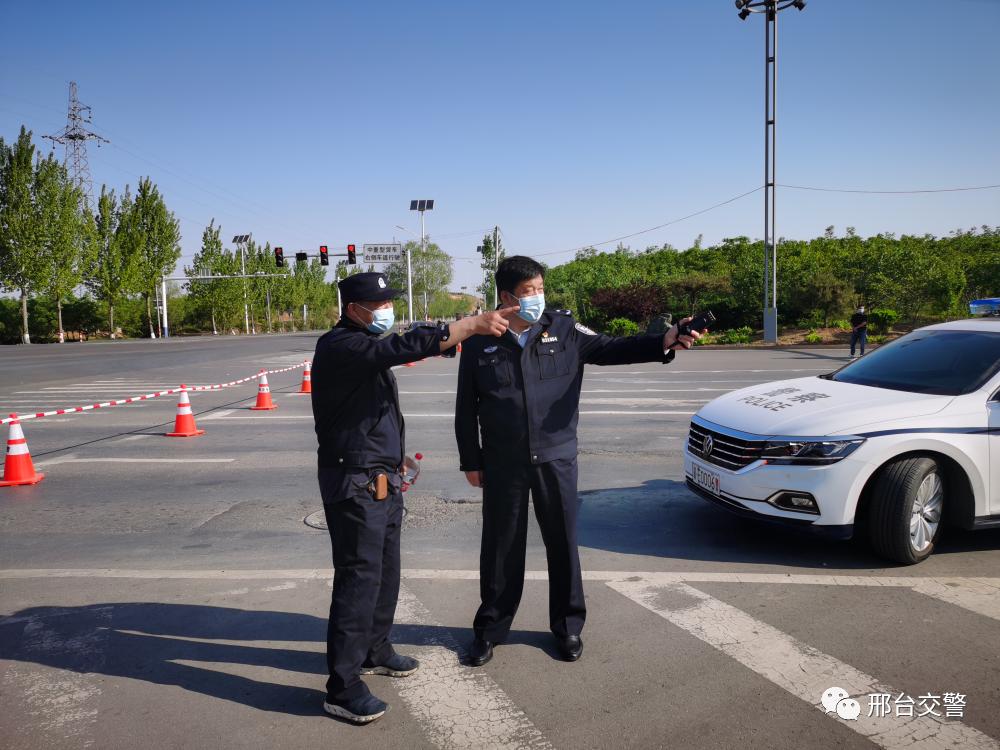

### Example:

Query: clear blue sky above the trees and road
xmin=0 ymin=0 xmax=1000 ymax=289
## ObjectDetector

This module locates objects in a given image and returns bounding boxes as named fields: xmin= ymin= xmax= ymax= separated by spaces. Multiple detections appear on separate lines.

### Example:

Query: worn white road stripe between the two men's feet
xmin=396 ymin=586 xmax=552 ymax=750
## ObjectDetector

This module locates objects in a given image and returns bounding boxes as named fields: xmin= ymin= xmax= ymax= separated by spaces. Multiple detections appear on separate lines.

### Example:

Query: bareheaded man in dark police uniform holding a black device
xmin=455 ymin=256 xmax=699 ymax=666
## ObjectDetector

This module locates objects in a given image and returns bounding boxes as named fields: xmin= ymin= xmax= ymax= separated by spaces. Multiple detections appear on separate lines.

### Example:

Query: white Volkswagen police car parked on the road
xmin=684 ymin=319 xmax=1000 ymax=563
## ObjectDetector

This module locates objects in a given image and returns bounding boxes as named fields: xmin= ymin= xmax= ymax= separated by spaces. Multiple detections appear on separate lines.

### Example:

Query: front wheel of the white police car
xmin=868 ymin=457 xmax=946 ymax=565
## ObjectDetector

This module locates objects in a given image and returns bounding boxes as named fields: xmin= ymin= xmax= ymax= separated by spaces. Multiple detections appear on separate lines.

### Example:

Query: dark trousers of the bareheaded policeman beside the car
xmin=473 ymin=455 xmax=587 ymax=642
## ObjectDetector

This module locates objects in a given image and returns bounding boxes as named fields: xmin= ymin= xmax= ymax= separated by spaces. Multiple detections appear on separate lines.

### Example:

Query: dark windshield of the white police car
xmin=830 ymin=330 xmax=1000 ymax=396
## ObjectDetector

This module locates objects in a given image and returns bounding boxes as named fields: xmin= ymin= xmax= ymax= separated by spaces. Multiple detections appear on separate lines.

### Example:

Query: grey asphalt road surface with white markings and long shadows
xmin=0 ymin=334 xmax=1000 ymax=749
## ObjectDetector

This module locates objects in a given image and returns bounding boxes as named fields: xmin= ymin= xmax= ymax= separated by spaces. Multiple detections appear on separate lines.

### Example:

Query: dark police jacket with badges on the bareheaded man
xmin=455 ymin=310 xmax=674 ymax=471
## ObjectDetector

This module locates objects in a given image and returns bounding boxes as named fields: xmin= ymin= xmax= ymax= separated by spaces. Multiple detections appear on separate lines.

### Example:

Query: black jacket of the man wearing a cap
xmin=312 ymin=319 xmax=442 ymax=471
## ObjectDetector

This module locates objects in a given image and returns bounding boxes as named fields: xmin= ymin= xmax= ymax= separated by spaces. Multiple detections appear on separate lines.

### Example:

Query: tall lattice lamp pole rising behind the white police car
xmin=736 ymin=0 xmax=806 ymax=344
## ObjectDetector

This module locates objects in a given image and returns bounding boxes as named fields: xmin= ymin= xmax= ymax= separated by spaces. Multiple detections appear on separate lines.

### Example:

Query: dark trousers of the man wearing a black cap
xmin=319 ymin=469 xmax=403 ymax=700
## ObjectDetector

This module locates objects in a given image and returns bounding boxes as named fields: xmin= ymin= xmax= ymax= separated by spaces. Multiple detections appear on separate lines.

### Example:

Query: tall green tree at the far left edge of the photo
xmin=0 ymin=126 xmax=48 ymax=344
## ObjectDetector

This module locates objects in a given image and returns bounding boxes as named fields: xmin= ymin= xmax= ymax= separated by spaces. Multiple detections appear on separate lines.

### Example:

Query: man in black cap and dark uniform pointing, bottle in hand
xmin=312 ymin=273 xmax=517 ymax=724
